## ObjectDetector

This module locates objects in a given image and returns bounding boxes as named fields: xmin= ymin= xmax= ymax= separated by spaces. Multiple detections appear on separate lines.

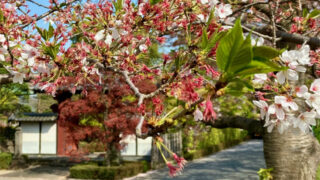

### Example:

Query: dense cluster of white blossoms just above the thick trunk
xmin=253 ymin=45 xmax=320 ymax=133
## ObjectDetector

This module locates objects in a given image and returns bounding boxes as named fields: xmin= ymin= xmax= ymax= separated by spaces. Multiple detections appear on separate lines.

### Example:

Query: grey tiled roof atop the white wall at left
xmin=9 ymin=113 xmax=58 ymax=122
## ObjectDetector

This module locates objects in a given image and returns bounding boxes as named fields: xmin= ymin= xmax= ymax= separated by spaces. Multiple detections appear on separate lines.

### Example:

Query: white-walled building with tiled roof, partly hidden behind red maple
xmin=9 ymin=113 xmax=152 ymax=160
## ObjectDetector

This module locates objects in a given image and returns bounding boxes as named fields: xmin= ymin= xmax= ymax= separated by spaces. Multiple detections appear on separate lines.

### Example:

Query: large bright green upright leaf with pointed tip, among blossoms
xmin=217 ymin=19 xmax=252 ymax=74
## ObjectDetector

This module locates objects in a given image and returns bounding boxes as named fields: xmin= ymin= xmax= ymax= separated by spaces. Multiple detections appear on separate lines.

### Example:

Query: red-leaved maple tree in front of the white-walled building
xmin=58 ymin=73 xmax=156 ymax=165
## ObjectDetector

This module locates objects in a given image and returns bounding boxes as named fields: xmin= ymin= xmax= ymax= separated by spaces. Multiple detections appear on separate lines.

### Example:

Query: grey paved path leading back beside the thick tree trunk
xmin=126 ymin=140 xmax=265 ymax=180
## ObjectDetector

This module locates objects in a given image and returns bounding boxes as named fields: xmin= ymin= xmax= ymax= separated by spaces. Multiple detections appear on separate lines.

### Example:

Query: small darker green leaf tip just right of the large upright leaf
xmin=252 ymin=46 xmax=280 ymax=59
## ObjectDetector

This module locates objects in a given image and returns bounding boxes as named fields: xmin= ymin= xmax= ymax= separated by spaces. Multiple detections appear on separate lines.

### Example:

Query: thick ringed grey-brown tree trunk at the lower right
xmin=263 ymin=127 xmax=320 ymax=180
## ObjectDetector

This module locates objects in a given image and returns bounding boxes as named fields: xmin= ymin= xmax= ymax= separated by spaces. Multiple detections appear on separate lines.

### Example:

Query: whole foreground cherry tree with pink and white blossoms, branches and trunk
xmin=0 ymin=0 xmax=320 ymax=179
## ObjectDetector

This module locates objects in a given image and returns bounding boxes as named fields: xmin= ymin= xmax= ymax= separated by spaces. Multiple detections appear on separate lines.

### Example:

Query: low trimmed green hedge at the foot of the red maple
xmin=70 ymin=162 xmax=149 ymax=180
